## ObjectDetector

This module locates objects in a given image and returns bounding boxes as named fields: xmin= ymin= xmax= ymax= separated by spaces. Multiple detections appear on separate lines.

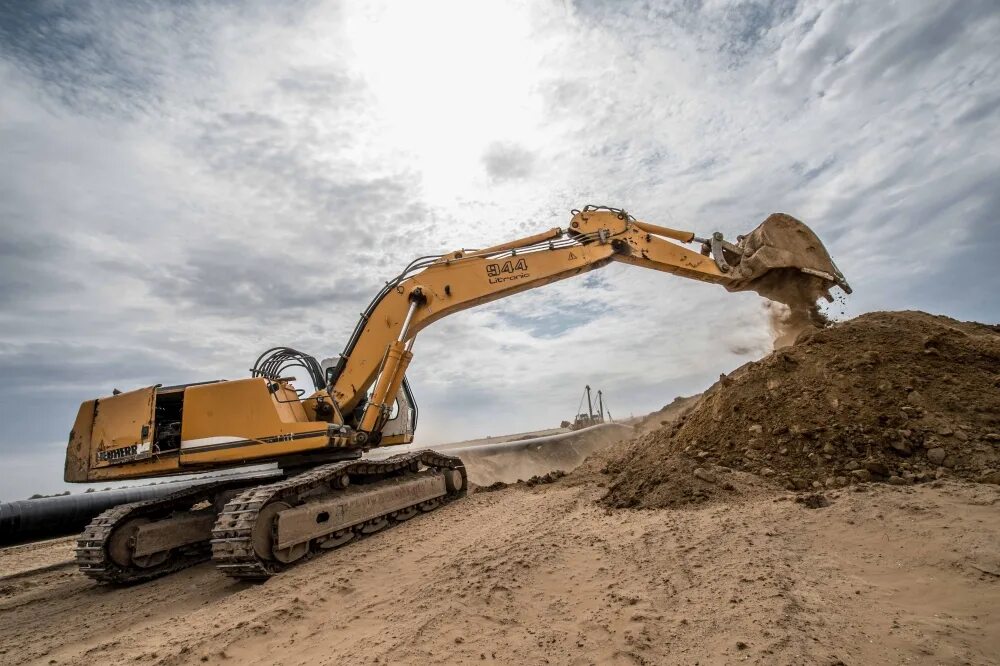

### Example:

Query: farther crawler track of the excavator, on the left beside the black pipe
xmin=76 ymin=478 xmax=259 ymax=585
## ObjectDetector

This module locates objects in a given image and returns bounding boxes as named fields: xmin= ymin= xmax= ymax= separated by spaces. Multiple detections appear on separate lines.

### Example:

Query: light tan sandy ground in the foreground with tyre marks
xmin=0 ymin=477 xmax=1000 ymax=664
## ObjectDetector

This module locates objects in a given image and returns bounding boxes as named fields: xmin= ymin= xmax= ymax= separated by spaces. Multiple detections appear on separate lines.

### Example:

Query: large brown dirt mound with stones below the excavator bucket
xmin=603 ymin=312 xmax=1000 ymax=507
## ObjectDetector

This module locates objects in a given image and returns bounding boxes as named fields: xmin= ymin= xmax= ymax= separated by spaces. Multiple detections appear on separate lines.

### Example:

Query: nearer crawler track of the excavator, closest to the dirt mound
xmin=212 ymin=451 xmax=468 ymax=580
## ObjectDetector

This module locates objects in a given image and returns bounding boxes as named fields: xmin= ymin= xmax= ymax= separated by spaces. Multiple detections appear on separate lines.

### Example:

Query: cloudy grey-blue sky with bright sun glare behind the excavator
xmin=0 ymin=0 xmax=1000 ymax=500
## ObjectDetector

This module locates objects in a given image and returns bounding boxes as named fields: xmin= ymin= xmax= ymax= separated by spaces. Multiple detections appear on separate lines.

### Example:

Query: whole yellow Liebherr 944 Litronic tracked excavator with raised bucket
xmin=64 ymin=205 xmax=850 ymax=584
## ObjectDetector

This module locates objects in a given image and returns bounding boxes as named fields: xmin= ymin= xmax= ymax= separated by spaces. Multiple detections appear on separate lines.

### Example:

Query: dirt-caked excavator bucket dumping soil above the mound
xmin=705 ymin=213 xmax=851 ymax=308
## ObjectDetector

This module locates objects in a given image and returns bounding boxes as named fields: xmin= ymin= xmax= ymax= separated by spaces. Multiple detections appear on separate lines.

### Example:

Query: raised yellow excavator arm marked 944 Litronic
xmin=328 ymin=206 xmax=850 ymax=443
